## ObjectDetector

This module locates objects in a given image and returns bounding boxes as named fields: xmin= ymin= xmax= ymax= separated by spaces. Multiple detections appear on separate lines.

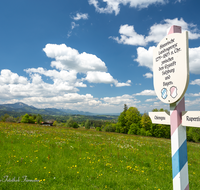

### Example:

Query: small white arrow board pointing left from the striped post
xmin=149 ymin=112 xmax=170 ymax=125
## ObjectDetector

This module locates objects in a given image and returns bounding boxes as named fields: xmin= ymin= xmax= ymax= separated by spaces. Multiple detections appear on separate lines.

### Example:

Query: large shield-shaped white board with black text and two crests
xmin=153 ymin=32 xmax=189 ymax=104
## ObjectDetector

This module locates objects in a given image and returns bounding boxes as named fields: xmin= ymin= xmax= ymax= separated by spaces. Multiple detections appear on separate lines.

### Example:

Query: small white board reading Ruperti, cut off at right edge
xmin=182 ymin=111 xmax=200 ymax=127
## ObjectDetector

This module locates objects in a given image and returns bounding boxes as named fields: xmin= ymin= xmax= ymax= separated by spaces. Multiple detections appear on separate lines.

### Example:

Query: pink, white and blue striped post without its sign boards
xmin=168 ymin=26 xmax=189 ymax=190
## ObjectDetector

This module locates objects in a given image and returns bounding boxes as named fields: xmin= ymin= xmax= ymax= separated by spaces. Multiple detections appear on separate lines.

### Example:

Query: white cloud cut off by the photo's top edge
xmin=88 ymin=0 xmax=165 ymax=15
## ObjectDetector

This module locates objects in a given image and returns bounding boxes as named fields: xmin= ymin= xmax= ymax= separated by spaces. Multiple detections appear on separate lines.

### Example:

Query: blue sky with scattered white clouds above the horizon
xmin=0 ymin=0 xmax=200 ymax=114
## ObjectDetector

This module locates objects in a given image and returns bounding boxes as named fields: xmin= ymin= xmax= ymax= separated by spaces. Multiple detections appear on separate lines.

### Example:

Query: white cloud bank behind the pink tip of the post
xmin=109 ymin=18 xmax=200 ymax=46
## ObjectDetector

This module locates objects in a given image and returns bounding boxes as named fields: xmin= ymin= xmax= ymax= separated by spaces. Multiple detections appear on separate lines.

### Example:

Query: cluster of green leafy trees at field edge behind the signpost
xmin=101 ymin=104 xmax=200 ymax=142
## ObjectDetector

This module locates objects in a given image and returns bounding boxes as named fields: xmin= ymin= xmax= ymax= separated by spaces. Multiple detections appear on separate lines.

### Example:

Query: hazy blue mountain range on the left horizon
xmin=0 ymin=102 xmax=96 ymax=115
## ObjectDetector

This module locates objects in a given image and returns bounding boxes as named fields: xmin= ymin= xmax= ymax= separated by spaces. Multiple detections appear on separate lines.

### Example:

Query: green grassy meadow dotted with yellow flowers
xmin=0 ymin=123 xmax=200 ymax=190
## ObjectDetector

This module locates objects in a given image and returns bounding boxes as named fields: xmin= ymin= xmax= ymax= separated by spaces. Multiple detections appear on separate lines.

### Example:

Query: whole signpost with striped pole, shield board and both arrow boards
xmin=149 ymin=26 xmax=192 ymax=190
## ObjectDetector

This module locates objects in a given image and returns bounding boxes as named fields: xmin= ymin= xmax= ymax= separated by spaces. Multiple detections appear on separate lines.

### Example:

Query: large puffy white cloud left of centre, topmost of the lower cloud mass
xmin=43 ymin=44 xmax=107 ymax=73
